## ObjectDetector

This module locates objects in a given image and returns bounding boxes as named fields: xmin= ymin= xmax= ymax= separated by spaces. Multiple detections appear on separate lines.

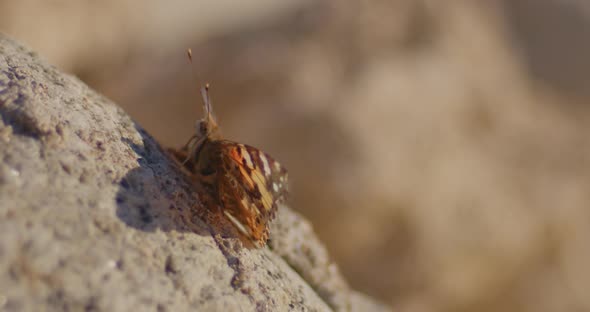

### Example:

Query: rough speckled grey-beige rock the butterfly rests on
xmin=0 ymin=34 xmax=388 ymax=311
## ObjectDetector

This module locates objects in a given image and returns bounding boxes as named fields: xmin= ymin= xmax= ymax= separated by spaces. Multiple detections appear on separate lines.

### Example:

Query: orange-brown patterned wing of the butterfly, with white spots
xmin=213 ymin=140 xmax=287 ymax=245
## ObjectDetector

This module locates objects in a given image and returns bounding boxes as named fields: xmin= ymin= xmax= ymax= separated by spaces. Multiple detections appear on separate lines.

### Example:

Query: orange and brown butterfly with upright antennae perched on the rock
xmin=173 ymin=81 xmax=288 ymax=247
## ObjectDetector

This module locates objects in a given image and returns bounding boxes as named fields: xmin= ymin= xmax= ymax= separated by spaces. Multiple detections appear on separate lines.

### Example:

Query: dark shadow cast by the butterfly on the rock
xmin=116 ymin=126 xmax=215 ymax=236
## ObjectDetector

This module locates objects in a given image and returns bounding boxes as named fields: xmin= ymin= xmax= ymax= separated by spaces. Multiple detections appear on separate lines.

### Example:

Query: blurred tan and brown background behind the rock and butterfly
xmin=0 ymin=0 xmax=590 ymax=312
